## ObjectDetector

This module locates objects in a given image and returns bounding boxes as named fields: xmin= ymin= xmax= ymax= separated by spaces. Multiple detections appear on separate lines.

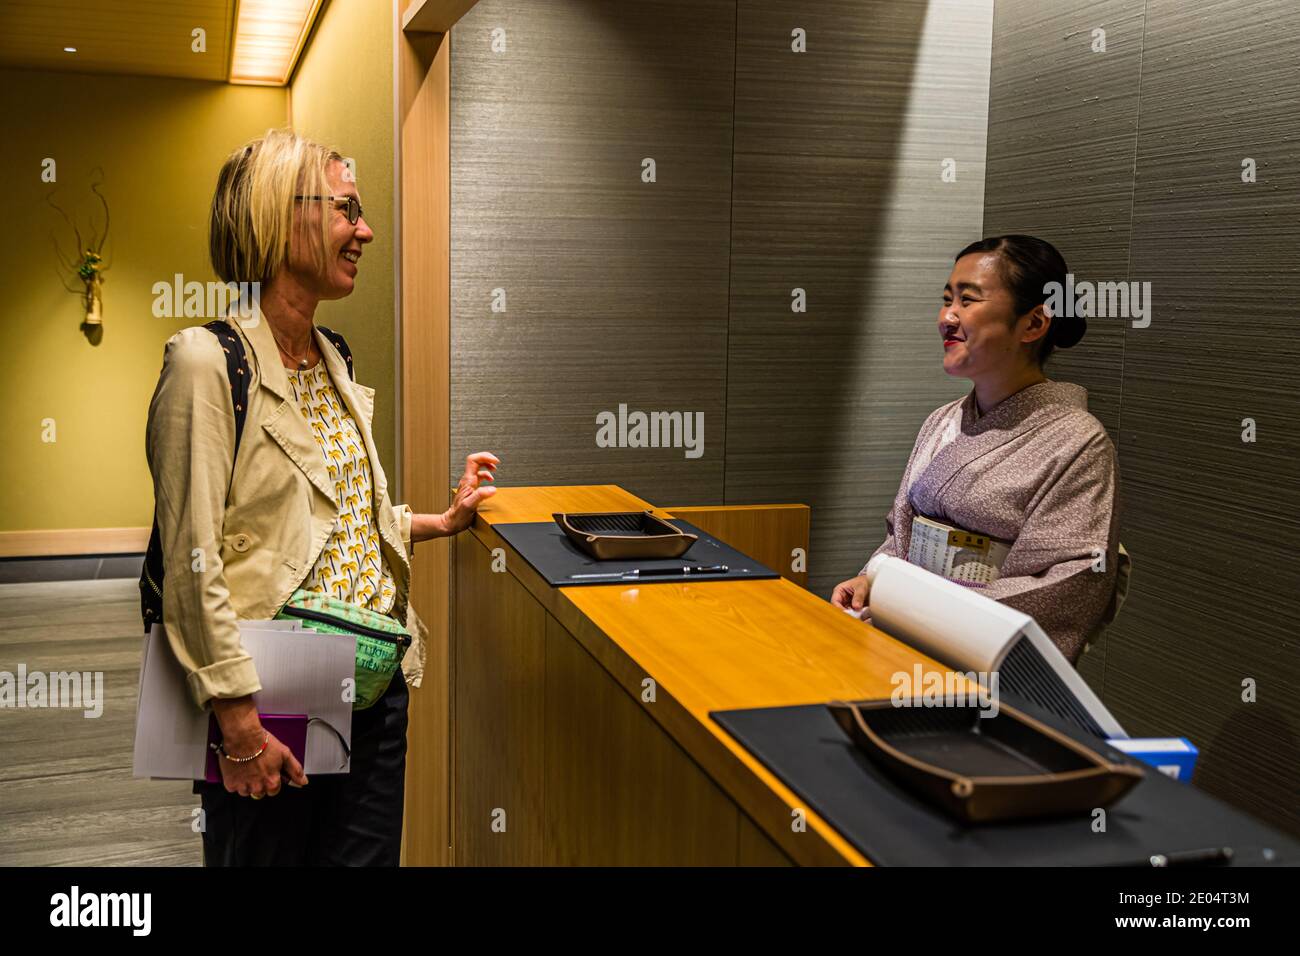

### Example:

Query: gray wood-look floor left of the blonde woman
xmin=0 ymin=579 xmax=202 ymax=866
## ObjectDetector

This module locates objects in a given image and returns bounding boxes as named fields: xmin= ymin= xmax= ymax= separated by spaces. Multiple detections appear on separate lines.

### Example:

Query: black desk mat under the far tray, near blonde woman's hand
xmin=493 ymin=518 xmax=780 ymax=588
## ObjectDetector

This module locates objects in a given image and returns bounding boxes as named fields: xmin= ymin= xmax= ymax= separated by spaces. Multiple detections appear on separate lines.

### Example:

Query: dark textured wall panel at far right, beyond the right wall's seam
xmin=1106 ymin=0 xmax=1300 ymax=832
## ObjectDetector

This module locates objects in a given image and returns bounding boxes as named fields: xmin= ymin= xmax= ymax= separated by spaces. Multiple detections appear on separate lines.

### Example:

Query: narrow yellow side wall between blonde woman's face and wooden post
xmin=290 ymin=0 xmax=398 ymax=494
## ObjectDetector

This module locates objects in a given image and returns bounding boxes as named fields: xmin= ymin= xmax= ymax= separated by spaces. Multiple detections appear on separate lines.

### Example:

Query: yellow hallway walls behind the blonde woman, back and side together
xmin=0 ymin=0 xmax=395 ymax=546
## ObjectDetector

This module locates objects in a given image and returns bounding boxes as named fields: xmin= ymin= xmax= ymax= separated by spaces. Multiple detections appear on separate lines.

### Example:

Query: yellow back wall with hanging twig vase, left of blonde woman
xmin=0 ymin=70 xmax=287 ymax=531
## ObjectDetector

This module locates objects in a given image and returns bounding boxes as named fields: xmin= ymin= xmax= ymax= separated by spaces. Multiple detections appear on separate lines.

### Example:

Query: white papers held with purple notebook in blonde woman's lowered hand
xmin=133 ymin=620 xmax=356 ymax=780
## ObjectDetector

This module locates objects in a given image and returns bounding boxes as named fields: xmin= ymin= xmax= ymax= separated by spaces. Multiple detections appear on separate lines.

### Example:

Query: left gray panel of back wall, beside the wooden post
xmin=451 ymin=0 xmax=736 ymax=503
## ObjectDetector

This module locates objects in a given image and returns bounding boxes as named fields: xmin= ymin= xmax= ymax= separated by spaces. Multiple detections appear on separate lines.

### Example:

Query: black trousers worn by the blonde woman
xmin=194 ymin=669 xmax=410 ymax=866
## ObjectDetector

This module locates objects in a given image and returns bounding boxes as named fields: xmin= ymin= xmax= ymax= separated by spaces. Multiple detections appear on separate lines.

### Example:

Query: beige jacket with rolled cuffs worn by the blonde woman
xmin=146 ymin=317 xmax=424 ymax=708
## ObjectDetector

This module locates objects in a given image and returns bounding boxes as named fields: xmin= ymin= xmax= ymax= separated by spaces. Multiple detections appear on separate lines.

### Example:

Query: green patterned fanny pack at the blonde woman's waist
xmin=276 ymin=588 xmax=411 ymax=710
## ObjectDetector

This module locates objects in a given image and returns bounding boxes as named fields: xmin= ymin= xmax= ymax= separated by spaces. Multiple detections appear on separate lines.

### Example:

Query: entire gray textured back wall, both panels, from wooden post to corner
xmin=451 ymin=0 xmax=992 ymax=593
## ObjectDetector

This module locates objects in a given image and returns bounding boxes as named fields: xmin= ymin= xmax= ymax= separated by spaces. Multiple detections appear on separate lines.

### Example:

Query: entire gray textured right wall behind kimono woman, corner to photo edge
xmin=984 ymin=0 xmax=1300 ymax=832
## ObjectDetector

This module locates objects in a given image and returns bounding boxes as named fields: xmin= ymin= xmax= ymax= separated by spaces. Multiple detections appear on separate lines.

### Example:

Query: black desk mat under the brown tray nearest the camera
xmin=710 ymin=693 xmax=1300 ymax=866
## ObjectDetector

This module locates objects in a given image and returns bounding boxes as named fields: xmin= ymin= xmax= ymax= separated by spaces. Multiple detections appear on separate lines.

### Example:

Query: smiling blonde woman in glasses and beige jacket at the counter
xmin=147 ymin=130 xmax=499 ymax=866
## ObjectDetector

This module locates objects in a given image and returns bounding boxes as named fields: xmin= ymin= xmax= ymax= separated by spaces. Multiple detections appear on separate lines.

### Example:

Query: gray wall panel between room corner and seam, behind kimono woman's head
xmin=984 ymin=0 xmax=1144 ymax=438
